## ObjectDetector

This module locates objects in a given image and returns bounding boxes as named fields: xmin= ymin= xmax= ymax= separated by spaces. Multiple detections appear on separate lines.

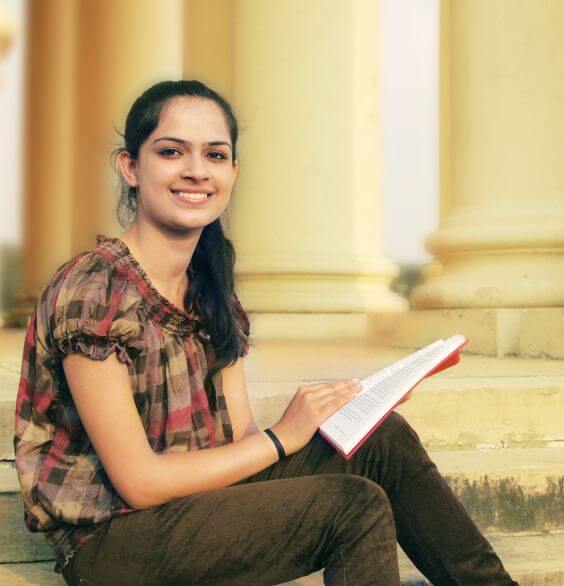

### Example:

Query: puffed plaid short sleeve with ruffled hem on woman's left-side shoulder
xmin=46 ymin=254 xmax=140 ymax=363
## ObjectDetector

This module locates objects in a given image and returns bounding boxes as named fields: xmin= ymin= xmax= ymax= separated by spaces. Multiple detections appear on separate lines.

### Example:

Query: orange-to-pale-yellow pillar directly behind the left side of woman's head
xmin=73 ymin=0 xmax=183 ymax=250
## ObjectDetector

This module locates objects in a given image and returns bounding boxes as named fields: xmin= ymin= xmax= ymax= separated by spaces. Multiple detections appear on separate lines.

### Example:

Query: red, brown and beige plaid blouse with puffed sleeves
xmin=14 ymin=235 xmax=249 ymax=573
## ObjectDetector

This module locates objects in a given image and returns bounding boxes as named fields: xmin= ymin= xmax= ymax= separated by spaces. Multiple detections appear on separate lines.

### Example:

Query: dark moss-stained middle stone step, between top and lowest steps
xmin=0 ymin=447 xmax=564 ymax=563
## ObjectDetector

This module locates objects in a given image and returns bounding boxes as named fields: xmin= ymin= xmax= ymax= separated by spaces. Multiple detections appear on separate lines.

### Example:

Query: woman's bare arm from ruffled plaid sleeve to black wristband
xmin=63 ymin=353 xmax=278 ymax=509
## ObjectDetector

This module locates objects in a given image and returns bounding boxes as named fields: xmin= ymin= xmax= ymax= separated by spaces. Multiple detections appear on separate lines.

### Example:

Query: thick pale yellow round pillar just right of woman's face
xmin=229 ymin=0 xmax=405 ymax=320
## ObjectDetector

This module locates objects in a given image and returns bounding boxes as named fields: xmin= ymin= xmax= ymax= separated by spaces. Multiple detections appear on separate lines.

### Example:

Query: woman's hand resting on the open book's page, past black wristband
xmin=272 ymin=379 xmax=362 ymax=455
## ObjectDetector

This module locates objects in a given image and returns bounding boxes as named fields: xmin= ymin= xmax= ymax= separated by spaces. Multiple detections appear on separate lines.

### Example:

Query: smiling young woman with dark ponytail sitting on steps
xmin=14 ymin=81 xmax=515 ymax=586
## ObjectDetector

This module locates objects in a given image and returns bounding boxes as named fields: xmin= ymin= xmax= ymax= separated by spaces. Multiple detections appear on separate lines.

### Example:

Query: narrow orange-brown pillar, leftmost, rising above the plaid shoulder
xmin=7 ymin=0 xmax=76 ymax=325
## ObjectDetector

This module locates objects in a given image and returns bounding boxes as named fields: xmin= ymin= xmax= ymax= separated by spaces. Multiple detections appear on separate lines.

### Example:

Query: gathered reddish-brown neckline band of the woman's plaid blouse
xmin=94 ymin=234 xmax=202 ymax=334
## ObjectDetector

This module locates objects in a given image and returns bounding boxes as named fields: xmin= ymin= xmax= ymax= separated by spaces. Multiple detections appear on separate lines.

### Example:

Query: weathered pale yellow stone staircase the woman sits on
xmin=0 ymin=330 xmax=564 ymax=586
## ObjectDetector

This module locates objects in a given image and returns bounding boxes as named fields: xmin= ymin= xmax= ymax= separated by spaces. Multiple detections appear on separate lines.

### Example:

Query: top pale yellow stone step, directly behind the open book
xmin=0 ymin=330 xmax=564 ymax=459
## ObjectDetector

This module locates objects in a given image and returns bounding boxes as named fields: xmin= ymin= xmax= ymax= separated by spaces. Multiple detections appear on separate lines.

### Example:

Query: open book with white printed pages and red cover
xmin=319 ymin=335 xmax=468 ymax=460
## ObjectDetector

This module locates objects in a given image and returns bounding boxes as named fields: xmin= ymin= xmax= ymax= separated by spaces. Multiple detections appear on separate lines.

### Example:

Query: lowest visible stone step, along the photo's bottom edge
xmin=0 ymin=533 xmax=564 ymax=586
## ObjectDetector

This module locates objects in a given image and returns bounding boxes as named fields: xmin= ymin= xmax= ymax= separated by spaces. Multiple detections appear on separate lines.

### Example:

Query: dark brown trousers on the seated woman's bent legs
xmin=63 ymin=413 xmax=517 ymax=586
